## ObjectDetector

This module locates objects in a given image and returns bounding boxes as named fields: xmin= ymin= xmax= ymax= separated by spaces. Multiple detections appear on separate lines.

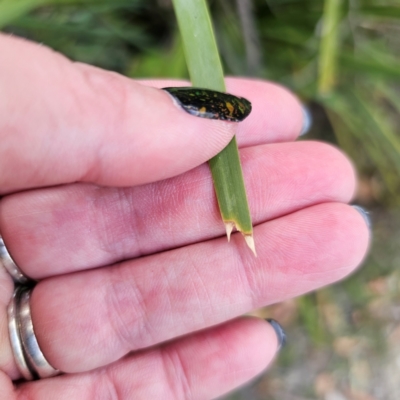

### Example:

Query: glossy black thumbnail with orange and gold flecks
xmin=163 ymin=87 xmax=251 ymax=122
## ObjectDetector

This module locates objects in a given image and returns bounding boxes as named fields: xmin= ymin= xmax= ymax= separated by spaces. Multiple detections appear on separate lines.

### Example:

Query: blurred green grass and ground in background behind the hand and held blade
xmin=0 ymin=0 xmax=400 ymax=400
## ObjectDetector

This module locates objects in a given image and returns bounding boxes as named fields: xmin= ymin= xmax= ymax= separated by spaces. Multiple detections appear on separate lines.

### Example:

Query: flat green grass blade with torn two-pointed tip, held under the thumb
xmin=173 ymin=0 xmax=255 ymax=253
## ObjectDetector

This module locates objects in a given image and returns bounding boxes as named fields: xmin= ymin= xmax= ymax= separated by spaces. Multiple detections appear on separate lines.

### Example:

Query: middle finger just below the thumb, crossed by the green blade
xmin=0 ymin=142 xmax=355 ymax=279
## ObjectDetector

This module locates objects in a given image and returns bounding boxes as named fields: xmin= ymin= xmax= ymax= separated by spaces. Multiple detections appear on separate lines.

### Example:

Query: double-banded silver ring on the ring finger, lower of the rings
xmin=8 ymin=286 xmax=60 ymax=380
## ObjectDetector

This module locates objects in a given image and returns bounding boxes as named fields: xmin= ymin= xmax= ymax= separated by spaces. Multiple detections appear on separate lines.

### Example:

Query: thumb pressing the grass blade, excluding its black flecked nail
xmin=0 ymin=34 xmax=239 ymax=194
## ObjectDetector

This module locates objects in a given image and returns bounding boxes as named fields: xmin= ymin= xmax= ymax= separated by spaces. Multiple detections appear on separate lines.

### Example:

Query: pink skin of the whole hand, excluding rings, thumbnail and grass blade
xmin=0 ymin=35 xmax=369 ymax=400
